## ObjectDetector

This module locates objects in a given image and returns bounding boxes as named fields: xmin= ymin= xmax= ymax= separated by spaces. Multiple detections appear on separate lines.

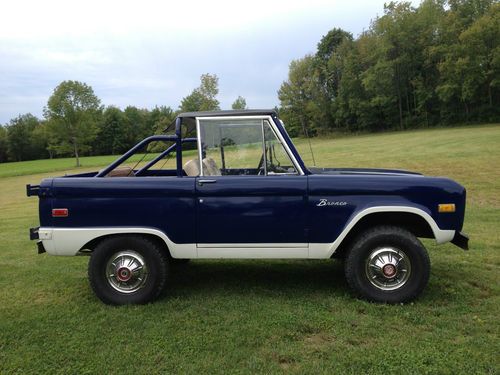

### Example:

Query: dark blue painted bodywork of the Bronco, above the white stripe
xmin=33 ymin=111 xmax=466 ymax=244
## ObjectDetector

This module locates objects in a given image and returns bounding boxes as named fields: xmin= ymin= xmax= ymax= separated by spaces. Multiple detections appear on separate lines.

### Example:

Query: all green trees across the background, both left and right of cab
xmin=0 ymin=0 xmax=500 ymax=165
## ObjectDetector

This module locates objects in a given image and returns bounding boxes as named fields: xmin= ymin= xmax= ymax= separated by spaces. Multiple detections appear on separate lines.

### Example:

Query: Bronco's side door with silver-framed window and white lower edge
xmin=196 ymin=118 xmax=308 ymax=258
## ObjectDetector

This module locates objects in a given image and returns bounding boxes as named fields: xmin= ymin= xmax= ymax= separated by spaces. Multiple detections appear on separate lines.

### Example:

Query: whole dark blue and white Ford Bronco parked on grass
xmin=27 ymin=110 xmax=468 ymax=305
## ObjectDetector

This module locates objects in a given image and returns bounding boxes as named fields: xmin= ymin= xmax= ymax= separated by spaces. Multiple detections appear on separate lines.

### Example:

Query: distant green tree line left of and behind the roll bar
xmin=0 ymin=74 xmax=247 ymax=166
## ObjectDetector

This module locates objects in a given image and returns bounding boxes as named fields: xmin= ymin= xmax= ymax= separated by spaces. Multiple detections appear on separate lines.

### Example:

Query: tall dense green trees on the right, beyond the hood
xmin=278 ymin=0 xmax=500 ymax=135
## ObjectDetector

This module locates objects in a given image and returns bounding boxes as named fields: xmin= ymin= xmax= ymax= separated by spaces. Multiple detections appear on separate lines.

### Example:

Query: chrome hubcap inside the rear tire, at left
xmin=106 ymin=250 xmax=148 ymax=293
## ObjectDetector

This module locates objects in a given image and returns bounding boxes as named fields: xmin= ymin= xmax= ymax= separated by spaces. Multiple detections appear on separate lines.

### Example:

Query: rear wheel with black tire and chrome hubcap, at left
xmin=88 ymin=236 xmax=168 ymax=305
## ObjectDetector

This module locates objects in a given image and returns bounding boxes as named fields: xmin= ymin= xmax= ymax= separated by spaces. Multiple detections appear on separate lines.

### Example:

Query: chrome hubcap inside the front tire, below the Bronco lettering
xmin=365 ymin=247 xmax=411 ymax=290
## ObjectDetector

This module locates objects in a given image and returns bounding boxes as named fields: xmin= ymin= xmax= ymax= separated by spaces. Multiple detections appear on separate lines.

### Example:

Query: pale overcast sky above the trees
xmin=0 ymin=0 xmax=418 ymax=124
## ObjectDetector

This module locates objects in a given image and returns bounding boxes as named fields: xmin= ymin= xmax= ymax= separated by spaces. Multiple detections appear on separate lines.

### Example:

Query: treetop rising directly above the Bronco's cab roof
xmin=179 ymin=73 xmax=220 ymax=112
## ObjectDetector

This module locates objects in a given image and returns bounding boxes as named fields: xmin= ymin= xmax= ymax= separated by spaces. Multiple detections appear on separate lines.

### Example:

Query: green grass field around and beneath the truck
xmin=0 ymin=125 xmax=500 ymax=374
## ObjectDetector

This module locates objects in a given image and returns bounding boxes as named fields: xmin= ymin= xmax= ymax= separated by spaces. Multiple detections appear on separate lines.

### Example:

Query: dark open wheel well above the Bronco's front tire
xmin=332 ymin=212 xmax=434 ymax=258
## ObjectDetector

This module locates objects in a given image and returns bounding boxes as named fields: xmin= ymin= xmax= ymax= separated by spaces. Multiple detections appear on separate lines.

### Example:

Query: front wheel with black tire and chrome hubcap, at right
xmin=344 ymin=226 xmax=430 ymax=303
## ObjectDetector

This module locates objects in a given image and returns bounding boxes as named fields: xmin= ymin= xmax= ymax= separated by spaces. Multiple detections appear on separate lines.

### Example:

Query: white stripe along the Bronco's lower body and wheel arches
xmin=38 ymin=206 xmax=455 ymax=259
